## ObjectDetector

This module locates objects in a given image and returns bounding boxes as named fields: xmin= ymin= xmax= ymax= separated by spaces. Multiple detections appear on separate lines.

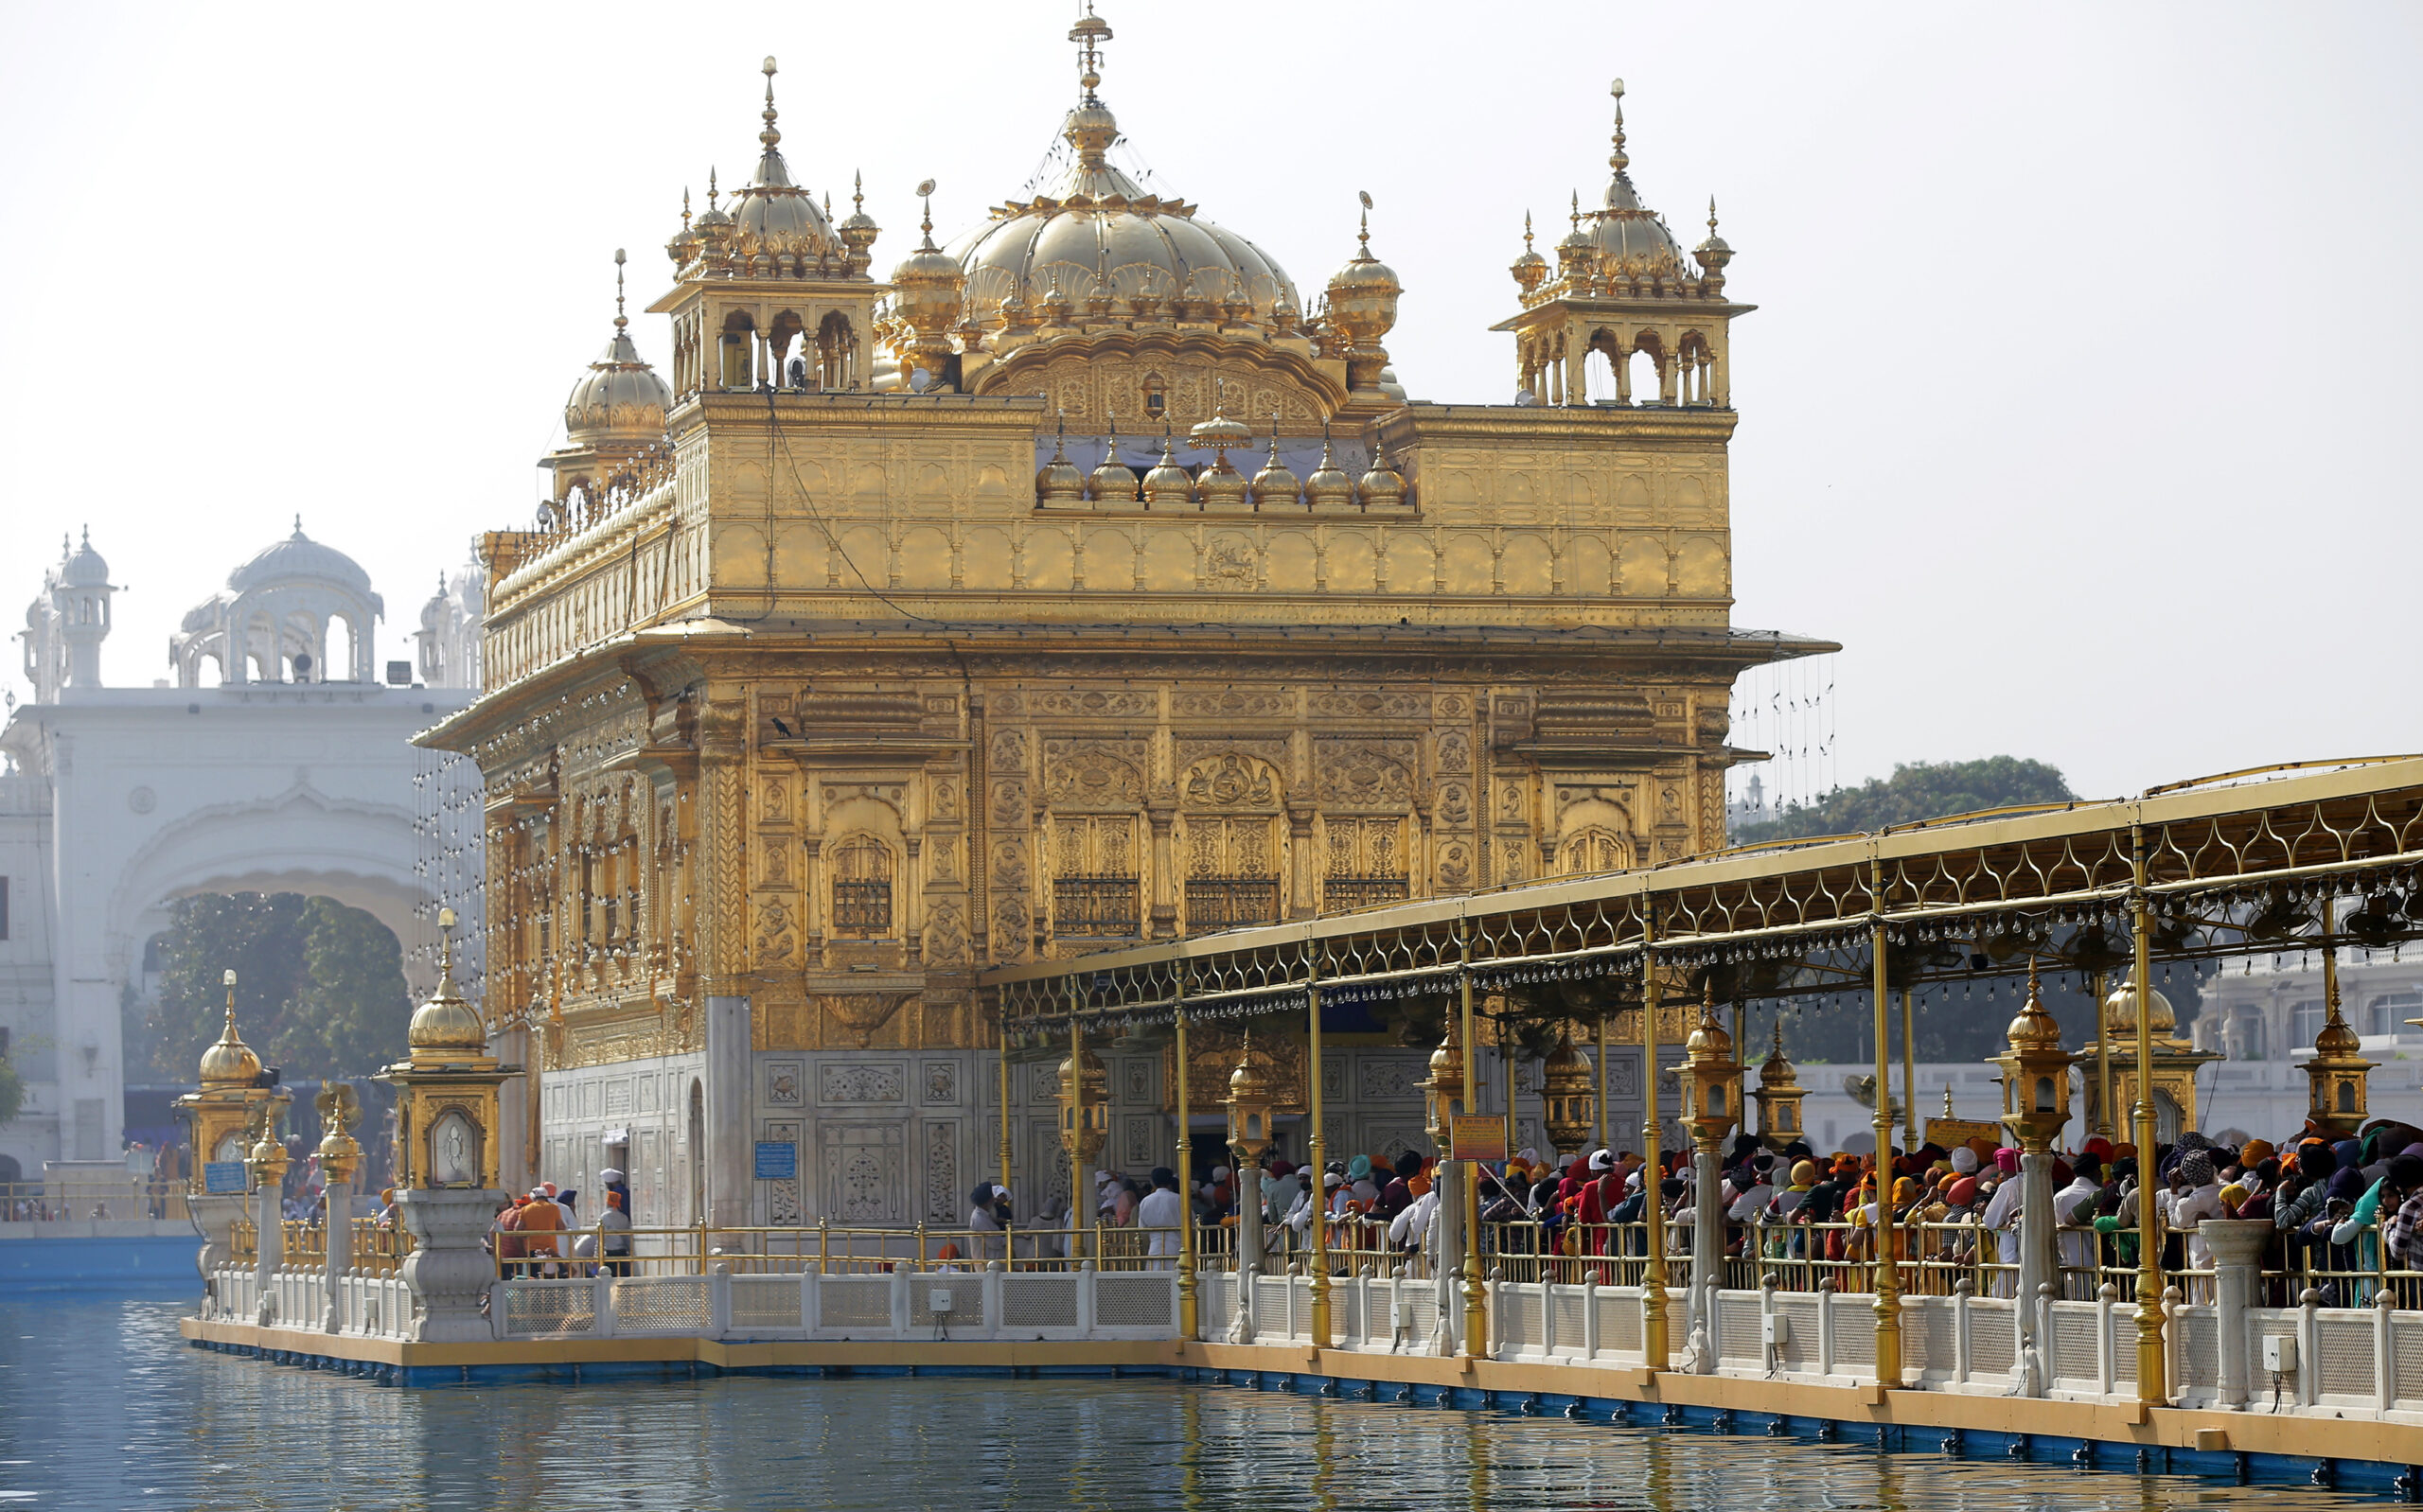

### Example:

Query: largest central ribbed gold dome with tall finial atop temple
xmin=950 ymin=9 xmax=1303 ymax=337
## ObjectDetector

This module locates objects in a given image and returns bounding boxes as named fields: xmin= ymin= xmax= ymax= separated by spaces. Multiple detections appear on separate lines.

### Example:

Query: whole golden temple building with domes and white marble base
xmin=429 ymin=14 xmax=1827 ymax=1222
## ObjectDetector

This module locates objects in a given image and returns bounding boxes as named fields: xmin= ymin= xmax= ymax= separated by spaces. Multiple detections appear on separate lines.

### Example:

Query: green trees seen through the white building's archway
xmin=129 ymin=891 xmax=412 ymax=1081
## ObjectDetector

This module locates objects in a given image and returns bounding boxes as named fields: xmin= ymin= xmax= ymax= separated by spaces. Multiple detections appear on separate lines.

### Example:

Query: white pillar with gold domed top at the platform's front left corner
xmin=378 ymin=908 xmax=521 ymax=1343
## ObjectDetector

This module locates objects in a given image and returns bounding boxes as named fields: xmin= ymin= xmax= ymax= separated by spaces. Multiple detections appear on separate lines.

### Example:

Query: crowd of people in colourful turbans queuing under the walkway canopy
xmin=1036 ymin=1119 xmax=2423 ymax=1306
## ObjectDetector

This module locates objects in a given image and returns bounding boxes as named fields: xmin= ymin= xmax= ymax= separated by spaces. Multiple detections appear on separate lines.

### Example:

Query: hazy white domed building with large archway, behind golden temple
xmin=0 ymin=523 xmax=482 ymax=1178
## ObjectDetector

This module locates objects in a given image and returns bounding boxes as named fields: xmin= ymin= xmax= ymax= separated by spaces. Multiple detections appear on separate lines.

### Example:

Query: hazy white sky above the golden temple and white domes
xmin=0 ymin=0 xmax=2423 ymax=795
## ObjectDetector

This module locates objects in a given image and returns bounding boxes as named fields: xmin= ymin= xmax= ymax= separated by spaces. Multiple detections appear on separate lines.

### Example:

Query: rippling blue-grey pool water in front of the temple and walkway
xmin=0 ymin=1296 xmax=2367 ymax=1512
